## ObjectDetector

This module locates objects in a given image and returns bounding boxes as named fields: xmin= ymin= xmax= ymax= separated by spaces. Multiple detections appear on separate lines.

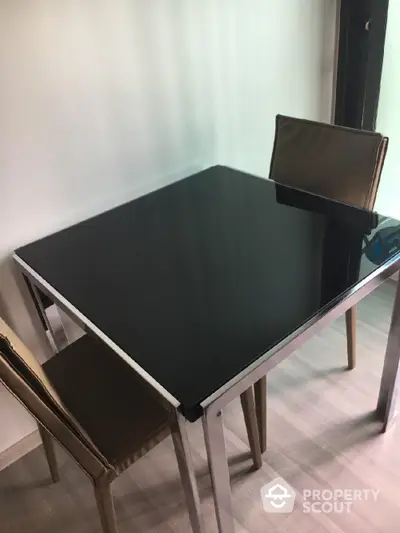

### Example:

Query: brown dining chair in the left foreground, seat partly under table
xmin=0 ymin=318 xmax=261 ymax=533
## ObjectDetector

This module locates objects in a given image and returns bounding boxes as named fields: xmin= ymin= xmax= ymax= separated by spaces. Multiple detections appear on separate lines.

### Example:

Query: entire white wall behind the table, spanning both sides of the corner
xmin=0 ymin=0 xmax=335 ymax=452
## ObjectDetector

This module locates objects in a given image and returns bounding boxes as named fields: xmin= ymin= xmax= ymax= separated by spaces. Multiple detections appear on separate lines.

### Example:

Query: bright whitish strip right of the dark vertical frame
xmin=375 ymin=0 xmax=400 ymax=218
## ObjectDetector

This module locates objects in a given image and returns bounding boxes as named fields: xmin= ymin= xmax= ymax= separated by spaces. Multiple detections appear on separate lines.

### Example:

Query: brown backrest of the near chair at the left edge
xmin=0 ymin=318 xmax=112 ymax=477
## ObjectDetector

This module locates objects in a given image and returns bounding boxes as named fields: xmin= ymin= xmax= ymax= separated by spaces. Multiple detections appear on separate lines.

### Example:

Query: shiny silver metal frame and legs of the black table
xmin=14 ymin=250 xmax=400 ymax=533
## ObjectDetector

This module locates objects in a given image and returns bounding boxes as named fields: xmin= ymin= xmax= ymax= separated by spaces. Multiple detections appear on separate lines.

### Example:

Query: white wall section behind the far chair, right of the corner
xmin=214 ymin=0 xmax=337 ymax=177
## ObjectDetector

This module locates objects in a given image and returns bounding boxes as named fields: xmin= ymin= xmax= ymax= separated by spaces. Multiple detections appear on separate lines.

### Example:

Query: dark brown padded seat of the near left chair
xmin=43 ymin=335 xmax=169 ymax=471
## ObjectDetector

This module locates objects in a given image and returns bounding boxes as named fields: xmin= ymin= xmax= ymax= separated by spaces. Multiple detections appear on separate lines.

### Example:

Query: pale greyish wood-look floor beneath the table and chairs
xmin=0 ymin=282 xmax=400 ymax=533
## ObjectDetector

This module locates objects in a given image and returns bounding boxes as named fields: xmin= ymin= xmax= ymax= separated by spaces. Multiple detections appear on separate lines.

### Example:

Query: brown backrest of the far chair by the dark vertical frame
xmin=269 ymin=115 xmax=388 ymax=210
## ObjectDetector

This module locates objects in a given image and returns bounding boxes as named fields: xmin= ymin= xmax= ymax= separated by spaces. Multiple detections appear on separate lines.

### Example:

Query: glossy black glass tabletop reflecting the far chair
xmin=17 ymin=166 xmax=400 ymax=419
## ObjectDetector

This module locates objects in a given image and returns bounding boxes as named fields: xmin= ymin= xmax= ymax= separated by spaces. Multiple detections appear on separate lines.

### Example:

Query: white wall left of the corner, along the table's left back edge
xmin=0 ymin=0 xmax=213 ymax=253
